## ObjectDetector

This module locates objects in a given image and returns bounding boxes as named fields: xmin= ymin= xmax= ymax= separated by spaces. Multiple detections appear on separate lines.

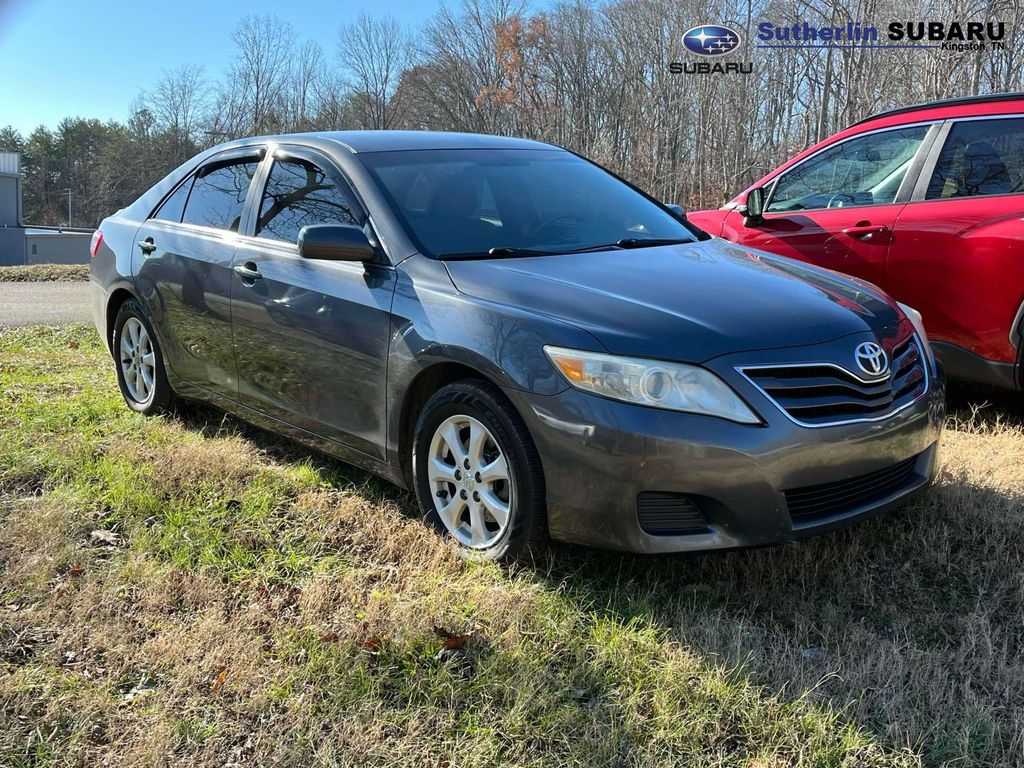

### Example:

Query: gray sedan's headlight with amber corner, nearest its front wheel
xmin=544 ymin=346 xmax=761 ymax=424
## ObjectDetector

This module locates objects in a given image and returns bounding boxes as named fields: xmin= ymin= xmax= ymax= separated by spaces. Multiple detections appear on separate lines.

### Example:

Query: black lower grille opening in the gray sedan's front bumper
xmin=785 ymin=456 xmax=918 ymax=525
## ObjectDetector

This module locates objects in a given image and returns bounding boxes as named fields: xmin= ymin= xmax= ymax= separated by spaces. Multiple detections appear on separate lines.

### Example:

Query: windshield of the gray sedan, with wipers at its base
xmin=359 ymin=150 xmax=696 ymax=258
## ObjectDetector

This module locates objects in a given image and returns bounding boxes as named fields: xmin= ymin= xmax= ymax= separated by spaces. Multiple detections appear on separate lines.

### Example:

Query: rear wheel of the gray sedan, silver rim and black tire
xmin=111 ymin=299 xmax=174 ymax=416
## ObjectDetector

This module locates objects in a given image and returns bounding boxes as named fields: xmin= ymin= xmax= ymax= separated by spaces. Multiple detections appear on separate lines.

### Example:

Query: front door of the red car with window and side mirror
xmin=722 ymin=124 xmax=930 ymax=287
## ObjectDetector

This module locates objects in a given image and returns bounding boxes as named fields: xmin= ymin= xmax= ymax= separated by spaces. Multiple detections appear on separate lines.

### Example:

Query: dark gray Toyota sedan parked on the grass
xmin=92 ymin=132 xmax=944 ymax=559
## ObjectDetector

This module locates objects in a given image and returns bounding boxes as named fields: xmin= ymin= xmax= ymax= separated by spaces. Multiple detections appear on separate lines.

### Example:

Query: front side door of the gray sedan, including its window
xmin=231 ymin=147 xmax=395 ymax=458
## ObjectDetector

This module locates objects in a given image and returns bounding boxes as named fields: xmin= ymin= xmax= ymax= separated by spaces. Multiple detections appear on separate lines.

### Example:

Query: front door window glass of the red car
xmin=765 ymin=125 xmax=929 ymax=213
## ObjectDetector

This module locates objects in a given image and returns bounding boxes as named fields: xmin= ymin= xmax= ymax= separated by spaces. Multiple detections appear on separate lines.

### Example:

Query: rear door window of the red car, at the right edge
xmin=927 ymin=119 xmax=1024 ymax=200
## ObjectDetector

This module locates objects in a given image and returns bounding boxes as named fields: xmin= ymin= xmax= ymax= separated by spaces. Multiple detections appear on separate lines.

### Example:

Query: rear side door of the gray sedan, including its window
xmin=134 ymin=147 xmax=261 ymax=398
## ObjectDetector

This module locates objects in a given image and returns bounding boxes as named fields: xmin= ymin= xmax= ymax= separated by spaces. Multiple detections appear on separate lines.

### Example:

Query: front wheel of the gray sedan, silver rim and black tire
xmin=412 ymin=381 xmax=546 ymax=561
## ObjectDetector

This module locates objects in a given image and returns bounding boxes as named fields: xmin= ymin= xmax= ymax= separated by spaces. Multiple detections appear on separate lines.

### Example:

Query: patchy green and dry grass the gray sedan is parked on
xmin=0 ymin=328 xmax=1024 ymax=768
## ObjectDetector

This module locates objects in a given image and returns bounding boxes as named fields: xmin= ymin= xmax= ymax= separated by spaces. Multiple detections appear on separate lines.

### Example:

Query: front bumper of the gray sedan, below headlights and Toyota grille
xmin=508 ymin=335 xmax=945 ymax=553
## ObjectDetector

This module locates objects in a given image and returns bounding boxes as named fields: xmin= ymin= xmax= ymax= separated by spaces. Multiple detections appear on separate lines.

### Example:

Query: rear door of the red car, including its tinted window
xmin=887 ymin=118 xmax=1024 ymax=362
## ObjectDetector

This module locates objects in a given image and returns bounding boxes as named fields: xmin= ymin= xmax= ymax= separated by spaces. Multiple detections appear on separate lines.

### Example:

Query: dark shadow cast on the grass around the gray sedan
xmin=165 ymin=399 xmax=1024 ymax=765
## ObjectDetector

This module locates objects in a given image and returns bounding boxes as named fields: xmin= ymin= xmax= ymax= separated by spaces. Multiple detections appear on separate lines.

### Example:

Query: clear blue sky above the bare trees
xmin=0 ymin=0 xmax=440 ymax=134
